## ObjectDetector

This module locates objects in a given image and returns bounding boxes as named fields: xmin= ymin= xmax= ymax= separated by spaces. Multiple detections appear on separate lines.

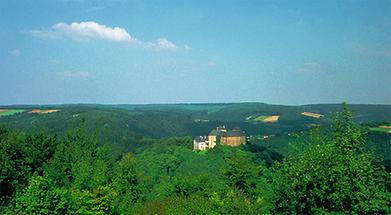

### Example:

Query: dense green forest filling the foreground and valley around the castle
xmin=0 ymin=105 xmax=391 ymax=214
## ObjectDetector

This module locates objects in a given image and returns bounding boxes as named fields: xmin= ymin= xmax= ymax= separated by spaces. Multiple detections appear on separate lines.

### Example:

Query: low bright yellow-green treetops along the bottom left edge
xmin=6 ymin=176 xmax=116 ymax=214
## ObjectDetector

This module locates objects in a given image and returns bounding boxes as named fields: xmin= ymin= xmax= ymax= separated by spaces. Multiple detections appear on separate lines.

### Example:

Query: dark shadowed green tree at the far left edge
xmin=0 ymin=128 xmax=57 ymax=205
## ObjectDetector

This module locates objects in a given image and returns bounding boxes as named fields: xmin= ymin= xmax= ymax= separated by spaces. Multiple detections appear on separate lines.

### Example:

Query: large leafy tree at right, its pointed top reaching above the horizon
xmin=272 ymin=105 xmax=391 ymax=214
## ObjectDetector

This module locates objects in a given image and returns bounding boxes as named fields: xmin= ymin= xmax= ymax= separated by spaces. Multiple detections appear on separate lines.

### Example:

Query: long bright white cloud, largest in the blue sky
xmin=27 ymin=21 xmax=191 ymax=51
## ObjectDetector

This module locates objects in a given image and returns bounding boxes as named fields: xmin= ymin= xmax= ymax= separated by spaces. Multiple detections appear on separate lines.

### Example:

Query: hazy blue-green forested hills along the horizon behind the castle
xmin=0 ymin=103 xmax=391 ymax=154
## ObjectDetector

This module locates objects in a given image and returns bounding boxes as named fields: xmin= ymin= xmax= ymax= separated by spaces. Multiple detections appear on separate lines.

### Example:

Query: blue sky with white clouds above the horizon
xmin=0 ymin=0 xmax=391 ymax=105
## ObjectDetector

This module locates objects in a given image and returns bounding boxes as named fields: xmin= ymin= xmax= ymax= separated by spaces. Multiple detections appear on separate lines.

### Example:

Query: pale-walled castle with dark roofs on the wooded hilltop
xmin=193 ymin=126 xmax=246 ymax=150
